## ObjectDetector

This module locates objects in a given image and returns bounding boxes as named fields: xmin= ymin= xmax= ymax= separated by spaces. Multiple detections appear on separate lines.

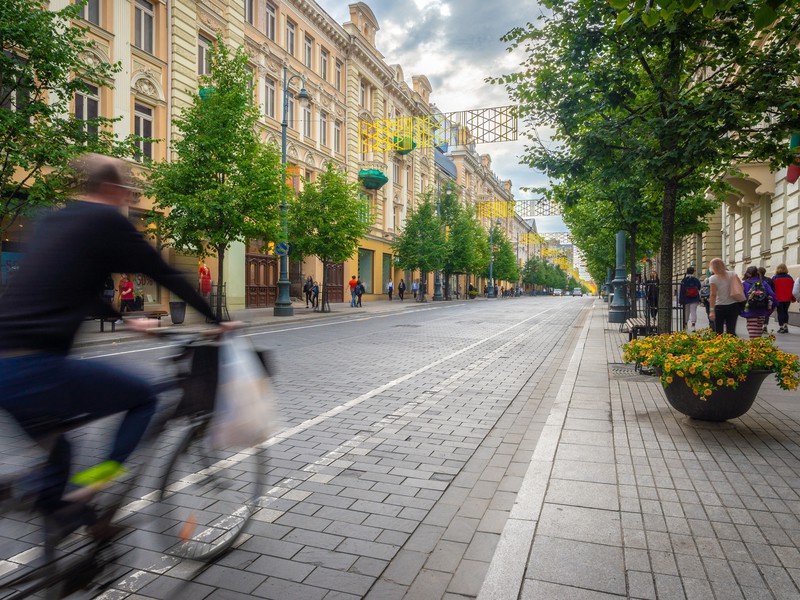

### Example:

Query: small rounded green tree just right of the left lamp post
xmin=289 ymin=162 xmax=372 ymax=312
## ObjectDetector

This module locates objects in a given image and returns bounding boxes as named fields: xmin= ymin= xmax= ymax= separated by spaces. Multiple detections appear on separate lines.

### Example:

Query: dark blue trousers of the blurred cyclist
xmin=0 ymin=354 xmax=156 ymax=509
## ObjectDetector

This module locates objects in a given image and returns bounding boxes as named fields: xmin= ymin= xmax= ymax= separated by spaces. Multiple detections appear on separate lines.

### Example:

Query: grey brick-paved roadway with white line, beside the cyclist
xmin=3 ymin=297 xmax=592 ymax=600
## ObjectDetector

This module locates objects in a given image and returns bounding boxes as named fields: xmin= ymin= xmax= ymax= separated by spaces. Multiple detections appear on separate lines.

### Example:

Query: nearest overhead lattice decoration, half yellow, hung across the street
xmin=359 ymin=106 xmax=517 ymax=154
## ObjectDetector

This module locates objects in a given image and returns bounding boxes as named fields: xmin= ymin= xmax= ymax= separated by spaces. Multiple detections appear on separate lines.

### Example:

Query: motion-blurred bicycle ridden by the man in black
xmin=0 ymin=331 xmax=271 ymax=600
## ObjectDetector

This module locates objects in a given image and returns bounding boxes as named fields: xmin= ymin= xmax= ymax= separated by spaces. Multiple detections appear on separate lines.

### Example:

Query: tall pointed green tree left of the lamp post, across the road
xmin=148 ymin=36 xmax=289 ymax=317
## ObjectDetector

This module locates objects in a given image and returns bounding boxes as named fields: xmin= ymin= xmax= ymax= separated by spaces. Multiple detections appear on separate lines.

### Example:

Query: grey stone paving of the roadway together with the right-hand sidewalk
xmin=6 ymin=298 xmax=800 ymax=600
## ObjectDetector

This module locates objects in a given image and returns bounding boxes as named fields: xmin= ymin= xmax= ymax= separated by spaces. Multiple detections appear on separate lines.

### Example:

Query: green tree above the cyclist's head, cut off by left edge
xmin=0 ymin=0 xmax=135 ymax=239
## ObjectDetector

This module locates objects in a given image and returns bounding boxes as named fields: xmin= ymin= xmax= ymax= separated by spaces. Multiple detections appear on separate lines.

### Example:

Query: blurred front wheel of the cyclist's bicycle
xmin=144 ymin=416 xmax=267 ymax=561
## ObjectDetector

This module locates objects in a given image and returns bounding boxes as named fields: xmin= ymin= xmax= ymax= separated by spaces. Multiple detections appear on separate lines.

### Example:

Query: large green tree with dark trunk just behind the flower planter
xmin=499 ymin=0 xmax=800 ymax=331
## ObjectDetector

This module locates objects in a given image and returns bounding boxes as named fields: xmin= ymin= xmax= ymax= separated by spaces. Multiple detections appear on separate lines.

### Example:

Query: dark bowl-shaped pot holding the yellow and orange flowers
xmin=664 ymin=371 xmax=771 ymax=421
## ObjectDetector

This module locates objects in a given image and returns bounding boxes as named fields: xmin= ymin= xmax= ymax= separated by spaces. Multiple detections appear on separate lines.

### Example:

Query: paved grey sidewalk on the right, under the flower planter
xmin=478 ymin=301 xmax=800 ymax=600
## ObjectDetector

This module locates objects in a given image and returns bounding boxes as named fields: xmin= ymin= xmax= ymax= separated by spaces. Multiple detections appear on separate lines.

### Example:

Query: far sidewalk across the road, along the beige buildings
xmin=74 ymin=296 xmax=450 ymax=348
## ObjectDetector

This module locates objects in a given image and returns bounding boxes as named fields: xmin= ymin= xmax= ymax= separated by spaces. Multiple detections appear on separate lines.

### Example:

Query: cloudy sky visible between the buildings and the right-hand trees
xmin=317 ymin=0 xmax=565 ymax=231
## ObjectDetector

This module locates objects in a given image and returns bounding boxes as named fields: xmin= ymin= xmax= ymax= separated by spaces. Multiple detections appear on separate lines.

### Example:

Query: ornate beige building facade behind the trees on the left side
xmin=40 ymin=0 xmax=529 ymax=310
